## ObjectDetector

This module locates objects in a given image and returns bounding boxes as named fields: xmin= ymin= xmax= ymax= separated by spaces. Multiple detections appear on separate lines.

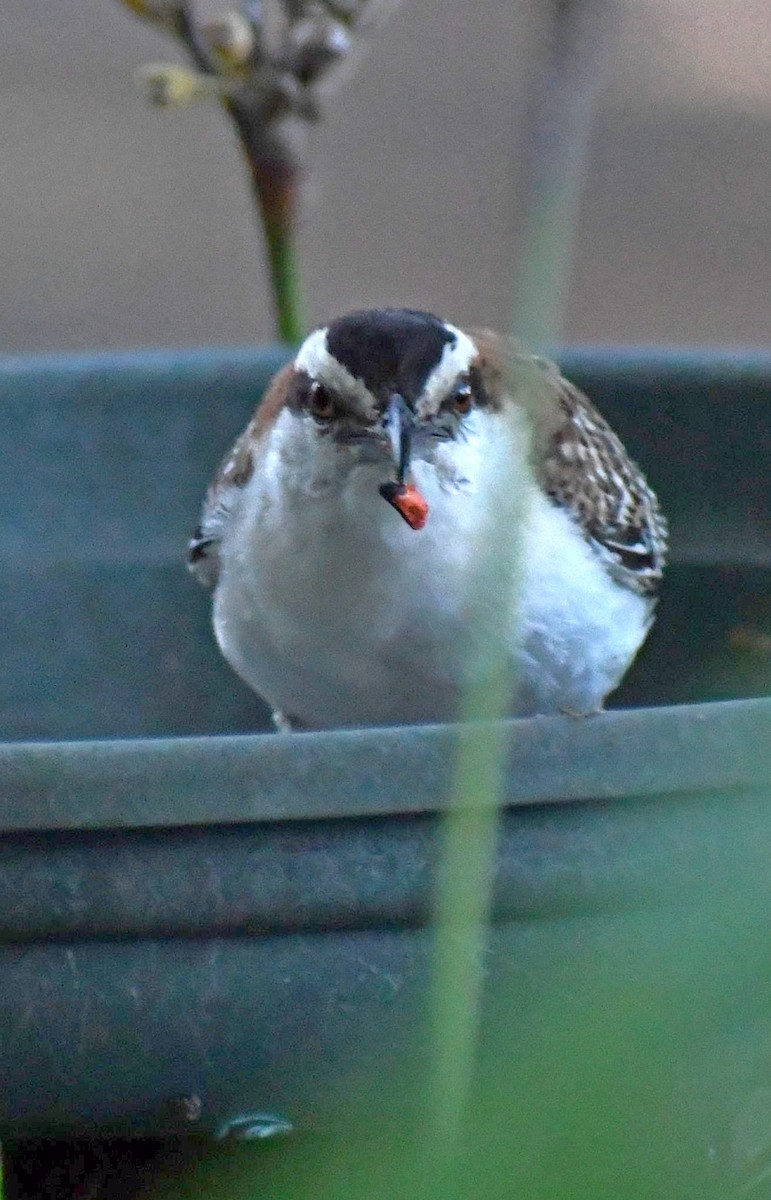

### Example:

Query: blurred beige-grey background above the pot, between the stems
xmin=0 ymin=0 xmax=771 ymax=353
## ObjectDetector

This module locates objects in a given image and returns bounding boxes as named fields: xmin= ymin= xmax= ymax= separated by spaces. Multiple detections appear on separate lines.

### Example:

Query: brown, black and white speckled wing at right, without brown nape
xmin=530 ymin=360 xmax=667 ymax=595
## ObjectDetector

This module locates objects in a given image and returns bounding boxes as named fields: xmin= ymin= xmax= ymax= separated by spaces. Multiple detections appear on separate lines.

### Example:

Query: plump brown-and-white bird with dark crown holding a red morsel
xmin=189 ymin=307 xmax=667 ymax=730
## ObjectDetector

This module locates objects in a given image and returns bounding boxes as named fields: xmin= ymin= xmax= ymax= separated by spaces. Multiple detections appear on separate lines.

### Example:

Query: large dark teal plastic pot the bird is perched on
xmin=0 ymin=348 xmax=771 ymax=1200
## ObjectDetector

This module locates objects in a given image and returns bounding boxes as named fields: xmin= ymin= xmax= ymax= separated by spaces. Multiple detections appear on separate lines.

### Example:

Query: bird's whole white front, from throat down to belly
xmin=214 ymin=413 xmax=650 ymax=726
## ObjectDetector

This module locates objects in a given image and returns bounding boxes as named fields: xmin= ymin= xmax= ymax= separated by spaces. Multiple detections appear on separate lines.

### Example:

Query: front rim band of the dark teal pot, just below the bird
xmin=0 ymin=700 xmax=771 ymax=833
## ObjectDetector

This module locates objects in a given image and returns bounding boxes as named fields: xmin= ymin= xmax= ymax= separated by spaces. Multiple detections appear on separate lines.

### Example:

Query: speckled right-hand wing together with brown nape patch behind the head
xmin=472 ymin=330 xmax=667 ymax=596
